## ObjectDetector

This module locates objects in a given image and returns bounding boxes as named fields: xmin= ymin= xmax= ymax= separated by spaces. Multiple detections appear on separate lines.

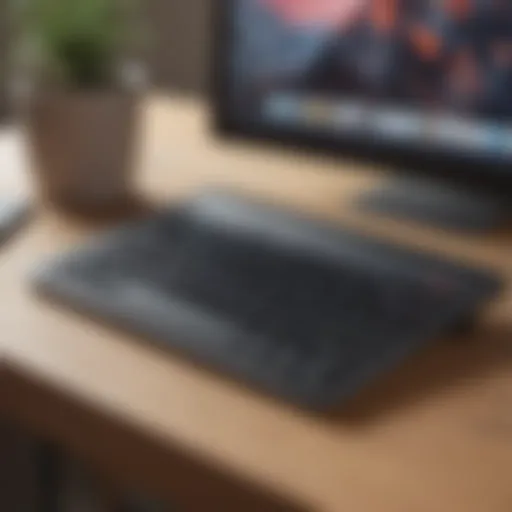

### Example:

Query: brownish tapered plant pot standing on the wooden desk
xmin=26 ymin=92 xmax=139 ymax=214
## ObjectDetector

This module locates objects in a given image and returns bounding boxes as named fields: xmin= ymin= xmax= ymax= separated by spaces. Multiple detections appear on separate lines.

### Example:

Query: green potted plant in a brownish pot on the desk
xmin=14 ymin=0 xmax=145 ymax=213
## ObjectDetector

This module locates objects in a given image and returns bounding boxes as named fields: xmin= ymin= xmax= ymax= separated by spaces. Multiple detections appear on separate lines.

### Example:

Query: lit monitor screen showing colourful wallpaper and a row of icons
xmin=231 ymin=0 xmax=512 ymax=156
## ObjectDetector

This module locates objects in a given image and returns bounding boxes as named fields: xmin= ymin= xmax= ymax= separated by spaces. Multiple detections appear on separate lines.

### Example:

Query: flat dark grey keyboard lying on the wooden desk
xmin=35 ymin=191 xmax=501 ymax=409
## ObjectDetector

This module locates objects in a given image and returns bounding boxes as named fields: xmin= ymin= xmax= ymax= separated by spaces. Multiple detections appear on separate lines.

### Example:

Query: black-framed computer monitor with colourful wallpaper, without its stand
xmin=215 ymin=0 xmax=512 ymax=229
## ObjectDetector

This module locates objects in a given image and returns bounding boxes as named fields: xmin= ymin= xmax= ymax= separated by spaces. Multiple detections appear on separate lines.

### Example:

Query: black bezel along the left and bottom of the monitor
xmin=210 ymin=0 xmax=512 ymax=200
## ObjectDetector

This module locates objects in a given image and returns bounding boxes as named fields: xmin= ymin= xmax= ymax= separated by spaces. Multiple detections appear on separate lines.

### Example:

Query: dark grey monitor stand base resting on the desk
xmin=358 ymin=178 xmax=512 ymax=232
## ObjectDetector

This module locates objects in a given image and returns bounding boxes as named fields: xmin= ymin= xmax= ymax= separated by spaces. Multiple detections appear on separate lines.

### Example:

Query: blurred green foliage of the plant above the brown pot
xmin=13 ymin=0 xmax=140 ymax=88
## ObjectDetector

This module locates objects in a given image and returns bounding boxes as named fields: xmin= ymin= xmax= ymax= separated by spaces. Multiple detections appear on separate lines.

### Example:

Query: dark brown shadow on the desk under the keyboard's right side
xmin=336 ymin=325 xmax=512 ymax=426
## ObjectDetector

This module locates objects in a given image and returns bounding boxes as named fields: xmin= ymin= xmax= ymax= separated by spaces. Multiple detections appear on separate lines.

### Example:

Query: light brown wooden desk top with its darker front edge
xmin=0 ymin=99 xmax=512 ymax=512
